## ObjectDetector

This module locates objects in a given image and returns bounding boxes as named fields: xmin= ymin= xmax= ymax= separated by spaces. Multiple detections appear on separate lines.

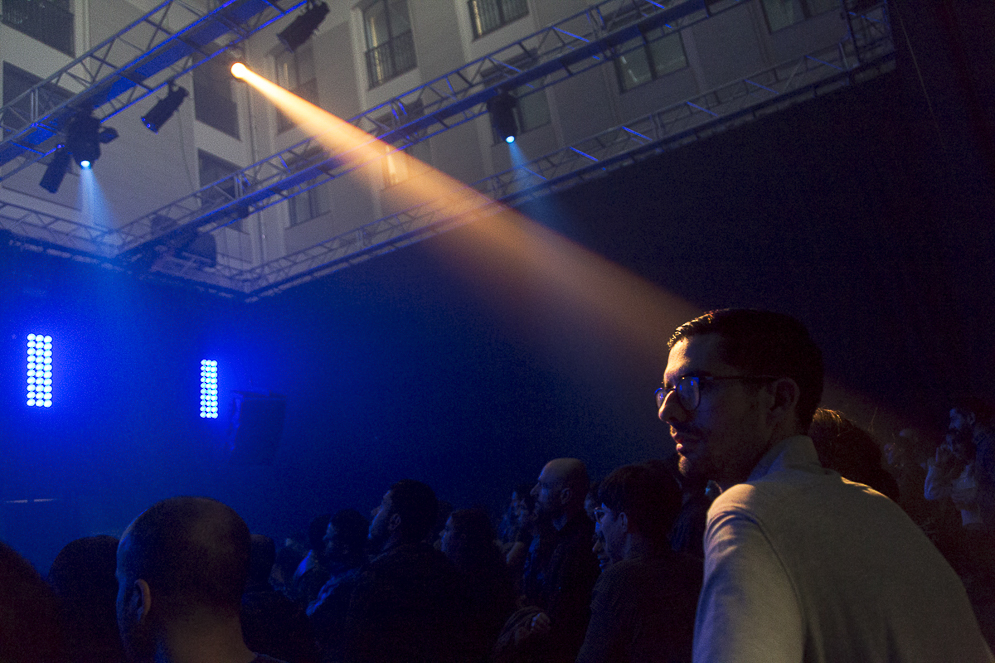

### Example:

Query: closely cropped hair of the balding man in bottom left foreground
xmin=122 ymin=497 xmax=250 ymax=612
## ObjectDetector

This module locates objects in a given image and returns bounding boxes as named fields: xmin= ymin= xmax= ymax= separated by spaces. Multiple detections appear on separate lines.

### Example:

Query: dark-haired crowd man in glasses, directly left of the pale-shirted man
xmin=577 ymin=465 xmax=701 ymax=663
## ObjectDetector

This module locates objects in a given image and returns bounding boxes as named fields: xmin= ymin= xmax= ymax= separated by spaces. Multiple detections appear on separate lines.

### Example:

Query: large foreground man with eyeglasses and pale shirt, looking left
xmin=656 ymin=309 xmax=993 ymax=663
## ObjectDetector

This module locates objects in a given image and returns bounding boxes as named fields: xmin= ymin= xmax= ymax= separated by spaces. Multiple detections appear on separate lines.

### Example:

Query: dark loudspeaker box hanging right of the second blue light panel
xmin=227 ymin=391 xmax=287 ymax=465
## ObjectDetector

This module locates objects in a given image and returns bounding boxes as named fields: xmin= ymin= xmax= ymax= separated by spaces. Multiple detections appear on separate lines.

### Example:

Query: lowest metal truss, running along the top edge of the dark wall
xmin=235 ymin=44 xmax=894 ymax=300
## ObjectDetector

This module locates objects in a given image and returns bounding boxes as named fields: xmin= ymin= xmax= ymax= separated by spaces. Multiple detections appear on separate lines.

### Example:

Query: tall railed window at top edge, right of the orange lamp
xmin=363 ymin=0 xmax=416 ymax=89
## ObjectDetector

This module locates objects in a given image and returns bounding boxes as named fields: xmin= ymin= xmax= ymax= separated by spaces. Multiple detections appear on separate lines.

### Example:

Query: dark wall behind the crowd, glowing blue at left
xmin=0 ymin=57 xmax=995 ymax=569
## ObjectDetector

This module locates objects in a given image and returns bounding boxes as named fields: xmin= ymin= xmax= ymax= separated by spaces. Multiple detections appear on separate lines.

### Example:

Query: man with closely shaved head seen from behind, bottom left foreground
xmin=116 ymin=497 xmax=288 ymax=663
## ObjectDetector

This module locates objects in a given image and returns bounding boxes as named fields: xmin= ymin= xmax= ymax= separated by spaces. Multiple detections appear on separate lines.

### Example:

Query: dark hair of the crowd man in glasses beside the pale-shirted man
xmin=598 ymin=465 xmax=681 ymax=550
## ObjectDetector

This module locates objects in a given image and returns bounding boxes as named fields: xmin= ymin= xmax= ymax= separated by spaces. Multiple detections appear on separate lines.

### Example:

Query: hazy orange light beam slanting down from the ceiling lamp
xmin=231 ymin=63 xmax=700 ymax=364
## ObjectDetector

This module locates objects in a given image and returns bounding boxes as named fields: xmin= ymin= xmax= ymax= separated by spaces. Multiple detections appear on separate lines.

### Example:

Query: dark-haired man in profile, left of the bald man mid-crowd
xmin=344 ymin=479 xmax=461 ymax=663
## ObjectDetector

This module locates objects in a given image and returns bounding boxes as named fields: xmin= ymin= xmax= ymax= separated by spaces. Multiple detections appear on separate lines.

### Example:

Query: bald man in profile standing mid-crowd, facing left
xmin=522 ymin=458 xmax=600 ymax=663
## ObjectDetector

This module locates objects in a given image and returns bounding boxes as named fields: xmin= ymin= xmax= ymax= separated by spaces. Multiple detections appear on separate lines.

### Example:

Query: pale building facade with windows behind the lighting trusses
xmin=0 ymin=0 xmax=872 ymax=294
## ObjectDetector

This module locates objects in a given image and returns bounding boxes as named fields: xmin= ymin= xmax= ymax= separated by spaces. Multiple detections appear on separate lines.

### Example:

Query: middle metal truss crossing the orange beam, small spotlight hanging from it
xmin=113 ymin=0 xmax=740 ymax=259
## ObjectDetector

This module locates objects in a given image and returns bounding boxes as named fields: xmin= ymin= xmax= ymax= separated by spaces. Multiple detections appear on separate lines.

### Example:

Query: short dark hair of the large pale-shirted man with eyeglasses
xmin=667 ymin=309 xmax=823 ymax=429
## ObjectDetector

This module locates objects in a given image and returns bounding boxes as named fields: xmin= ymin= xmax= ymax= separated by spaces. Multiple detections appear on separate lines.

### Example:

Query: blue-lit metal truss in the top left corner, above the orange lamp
xmin=0 ymin=0 xmax=305 ymax=181
